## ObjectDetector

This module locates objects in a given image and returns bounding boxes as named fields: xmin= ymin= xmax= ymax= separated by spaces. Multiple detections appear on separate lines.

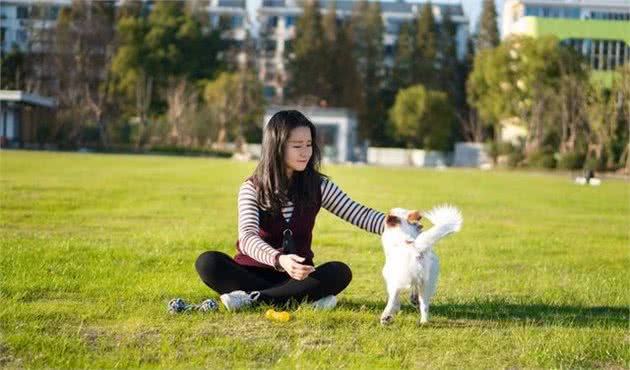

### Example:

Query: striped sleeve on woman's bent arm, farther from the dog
xmin=238 ymin=180 xmax=280 ymax=267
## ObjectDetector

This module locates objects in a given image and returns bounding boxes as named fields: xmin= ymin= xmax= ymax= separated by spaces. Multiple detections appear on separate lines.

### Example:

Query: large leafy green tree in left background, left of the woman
xmin=112 ymin=1 xmax=221 ymax=147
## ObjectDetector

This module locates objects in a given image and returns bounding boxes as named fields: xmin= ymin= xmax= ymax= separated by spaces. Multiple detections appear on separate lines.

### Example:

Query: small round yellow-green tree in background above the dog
xmin=389 ymin=85 xmax=454 ymax=150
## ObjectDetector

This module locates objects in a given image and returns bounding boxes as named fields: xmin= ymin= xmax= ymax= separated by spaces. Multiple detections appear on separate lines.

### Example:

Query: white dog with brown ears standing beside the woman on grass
xmin=381 ymin=205 xmax=463 ymax=325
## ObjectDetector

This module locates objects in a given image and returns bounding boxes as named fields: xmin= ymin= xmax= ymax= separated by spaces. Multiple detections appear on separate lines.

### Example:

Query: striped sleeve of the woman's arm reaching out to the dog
xmin=322 ymin=179 xmax=385 ymax=235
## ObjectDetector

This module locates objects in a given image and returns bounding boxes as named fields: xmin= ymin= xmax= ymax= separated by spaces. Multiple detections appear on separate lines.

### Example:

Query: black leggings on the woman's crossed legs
xmin=195 ymin=251 xmax=352 ymax=304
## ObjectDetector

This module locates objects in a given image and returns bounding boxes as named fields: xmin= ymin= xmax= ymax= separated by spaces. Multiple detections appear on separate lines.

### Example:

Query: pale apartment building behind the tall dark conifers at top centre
xmin=209 ymin=0 xmax=469 ymax=103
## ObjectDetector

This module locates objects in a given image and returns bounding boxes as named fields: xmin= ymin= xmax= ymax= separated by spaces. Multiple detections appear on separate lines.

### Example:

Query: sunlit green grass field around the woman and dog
xmin=0 ymin=151 xmax=630 ymax=369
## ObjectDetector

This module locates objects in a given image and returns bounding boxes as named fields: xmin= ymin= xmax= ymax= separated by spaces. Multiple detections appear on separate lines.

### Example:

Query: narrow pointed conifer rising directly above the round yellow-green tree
xmin=413 ymin=1 xmax=439 ymax=88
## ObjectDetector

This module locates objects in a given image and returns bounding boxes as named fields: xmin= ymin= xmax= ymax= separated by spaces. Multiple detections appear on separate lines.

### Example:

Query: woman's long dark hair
xmin=254 ymin=110 xmax=325 ymax=214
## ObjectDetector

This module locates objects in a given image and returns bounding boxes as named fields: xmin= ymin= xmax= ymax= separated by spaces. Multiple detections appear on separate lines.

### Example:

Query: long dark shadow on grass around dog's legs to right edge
xmin=338 ymin=298 xmax=630 ymax=328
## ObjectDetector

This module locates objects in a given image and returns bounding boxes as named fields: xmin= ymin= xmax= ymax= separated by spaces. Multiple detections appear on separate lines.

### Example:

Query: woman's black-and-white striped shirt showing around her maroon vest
xmin=238 ymin=179 xmax=385 ymax=266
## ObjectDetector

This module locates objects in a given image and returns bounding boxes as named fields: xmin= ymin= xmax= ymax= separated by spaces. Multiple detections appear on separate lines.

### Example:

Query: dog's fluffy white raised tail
xmin=414 ymin=204 xmax=464 ymax=252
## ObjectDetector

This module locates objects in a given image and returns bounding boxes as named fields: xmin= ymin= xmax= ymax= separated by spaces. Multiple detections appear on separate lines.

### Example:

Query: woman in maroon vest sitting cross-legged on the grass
xmin=195 ymin=110 xmax=385 ymax=311
